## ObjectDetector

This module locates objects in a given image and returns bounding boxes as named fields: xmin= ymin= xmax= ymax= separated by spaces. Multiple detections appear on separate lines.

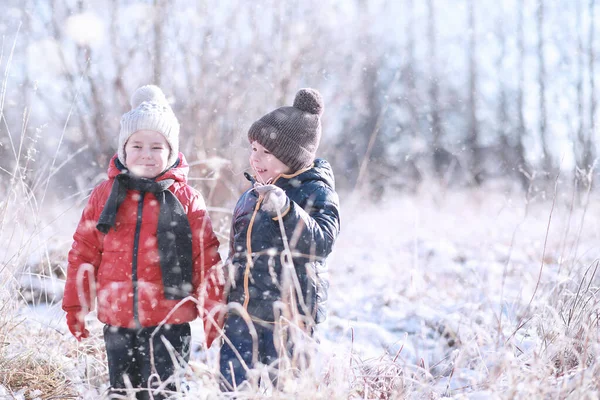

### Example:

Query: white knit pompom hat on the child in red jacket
xmin=118 ymin=85 xmax=179 ymax=167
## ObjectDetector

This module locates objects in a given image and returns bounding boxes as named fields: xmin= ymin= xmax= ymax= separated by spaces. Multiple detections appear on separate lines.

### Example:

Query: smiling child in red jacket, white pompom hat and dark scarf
xmin=63 ymin=85 xmax=223 ymax=399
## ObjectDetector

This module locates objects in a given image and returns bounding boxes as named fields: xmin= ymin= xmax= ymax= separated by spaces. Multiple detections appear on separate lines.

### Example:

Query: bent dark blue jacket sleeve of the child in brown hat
xmin=273 ymin=186 xmax=340 ymax=258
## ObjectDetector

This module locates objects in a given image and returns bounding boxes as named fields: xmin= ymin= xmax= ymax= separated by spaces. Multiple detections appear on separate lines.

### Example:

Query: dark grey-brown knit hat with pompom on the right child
xmin=248 ymin=88 xmax=323 ymax=172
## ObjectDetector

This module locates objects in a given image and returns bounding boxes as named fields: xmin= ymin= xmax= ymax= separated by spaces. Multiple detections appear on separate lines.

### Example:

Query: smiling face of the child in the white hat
xmin=125 ymin=130 xmax=171 ymax=178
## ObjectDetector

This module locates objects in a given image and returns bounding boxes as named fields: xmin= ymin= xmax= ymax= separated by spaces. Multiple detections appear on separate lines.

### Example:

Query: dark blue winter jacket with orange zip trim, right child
xmin=228 ymin=159 xmax=340 ymax=323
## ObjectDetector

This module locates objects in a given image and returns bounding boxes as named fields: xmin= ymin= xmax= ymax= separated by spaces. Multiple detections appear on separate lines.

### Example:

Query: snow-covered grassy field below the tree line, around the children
xmin=0 ymin=187 xmax=600 ymax=399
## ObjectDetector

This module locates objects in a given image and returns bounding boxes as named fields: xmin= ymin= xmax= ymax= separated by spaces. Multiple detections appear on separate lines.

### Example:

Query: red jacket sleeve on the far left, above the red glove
xmin=62 ymin=186 xmax=104 ymax=314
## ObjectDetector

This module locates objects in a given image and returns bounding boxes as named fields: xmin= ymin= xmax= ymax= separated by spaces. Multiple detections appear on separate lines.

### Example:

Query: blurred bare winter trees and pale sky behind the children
xmin=0 ymin=0 xmax=600 ymax=205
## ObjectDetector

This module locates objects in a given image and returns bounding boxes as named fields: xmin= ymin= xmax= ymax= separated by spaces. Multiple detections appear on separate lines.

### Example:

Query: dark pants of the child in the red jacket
xmin=104 ymin=323 xmax=191 ymax=399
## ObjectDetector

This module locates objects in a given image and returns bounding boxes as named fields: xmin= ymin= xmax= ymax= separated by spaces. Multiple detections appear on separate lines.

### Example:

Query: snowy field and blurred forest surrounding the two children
xmin=0 ymin=0 xmax=600 ymax=400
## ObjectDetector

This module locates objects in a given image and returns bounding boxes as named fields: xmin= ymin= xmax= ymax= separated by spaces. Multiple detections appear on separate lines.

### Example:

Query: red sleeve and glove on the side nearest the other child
xmin=188 ymin=194 xmax=225 ymax=347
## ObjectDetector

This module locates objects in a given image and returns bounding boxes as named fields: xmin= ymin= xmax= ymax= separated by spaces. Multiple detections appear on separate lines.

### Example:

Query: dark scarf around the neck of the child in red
xmin=96 ymin=173 xmax=192 ymax=300
